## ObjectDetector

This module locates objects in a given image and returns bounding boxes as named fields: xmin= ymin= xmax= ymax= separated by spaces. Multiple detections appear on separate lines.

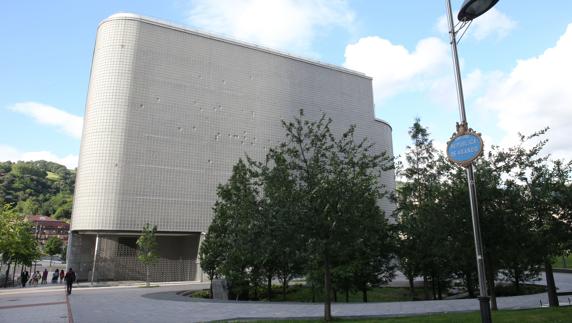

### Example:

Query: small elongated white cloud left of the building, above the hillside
xmin=8 ymin=102 xmax=83 ymax=139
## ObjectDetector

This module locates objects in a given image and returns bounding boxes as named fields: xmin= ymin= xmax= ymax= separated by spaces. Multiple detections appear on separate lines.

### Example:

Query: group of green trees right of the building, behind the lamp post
xmin=395 ymin=120 xmax=572 ymax=309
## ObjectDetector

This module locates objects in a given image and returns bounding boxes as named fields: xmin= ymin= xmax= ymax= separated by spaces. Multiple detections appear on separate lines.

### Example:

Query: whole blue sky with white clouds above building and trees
xmin=0 ymin=0 xmax=572 ymax=167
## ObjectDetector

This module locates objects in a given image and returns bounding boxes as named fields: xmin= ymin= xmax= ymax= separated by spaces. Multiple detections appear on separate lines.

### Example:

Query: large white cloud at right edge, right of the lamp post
xmin=477 ymin=24 xmax=572 ymax=159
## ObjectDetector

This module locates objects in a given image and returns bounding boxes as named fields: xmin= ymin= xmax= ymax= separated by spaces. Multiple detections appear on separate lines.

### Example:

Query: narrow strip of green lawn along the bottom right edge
xmin=250 ymin=307 xmax=572 ymax=323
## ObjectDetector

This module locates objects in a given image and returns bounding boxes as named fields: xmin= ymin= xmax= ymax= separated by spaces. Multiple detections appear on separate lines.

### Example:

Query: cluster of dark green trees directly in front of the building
xmin=201 ymin=111 xmax=394 ymax=320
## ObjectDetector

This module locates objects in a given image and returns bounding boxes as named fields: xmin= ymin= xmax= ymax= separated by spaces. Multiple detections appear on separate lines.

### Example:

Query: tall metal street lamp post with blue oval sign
xmin=446 ymin=0 xmax=498 ymax=323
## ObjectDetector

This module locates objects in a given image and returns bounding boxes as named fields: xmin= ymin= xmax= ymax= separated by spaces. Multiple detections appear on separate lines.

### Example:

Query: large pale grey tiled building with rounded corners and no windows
xmin=69 ymin=14 xmax=395 ymax=281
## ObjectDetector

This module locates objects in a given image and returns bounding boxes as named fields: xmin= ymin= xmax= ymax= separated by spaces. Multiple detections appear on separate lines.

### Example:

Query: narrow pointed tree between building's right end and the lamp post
xmin=395 ymin=119 xmax=450 ymax=298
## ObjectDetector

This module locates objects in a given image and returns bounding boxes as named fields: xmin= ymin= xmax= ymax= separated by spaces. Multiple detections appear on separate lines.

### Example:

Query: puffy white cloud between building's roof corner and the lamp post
xmin=344 ymin=36 xmax=451 ymax=104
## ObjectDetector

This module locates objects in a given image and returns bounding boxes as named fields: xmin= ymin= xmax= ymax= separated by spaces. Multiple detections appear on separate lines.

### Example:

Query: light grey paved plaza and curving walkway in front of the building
xmin=0 ymin=273 xmax=572 ymax=323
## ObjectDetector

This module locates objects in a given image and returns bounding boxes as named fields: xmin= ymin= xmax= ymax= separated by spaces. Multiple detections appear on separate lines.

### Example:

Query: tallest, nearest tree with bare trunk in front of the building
xmin=277 ymin=111 xmax=392 ymax=320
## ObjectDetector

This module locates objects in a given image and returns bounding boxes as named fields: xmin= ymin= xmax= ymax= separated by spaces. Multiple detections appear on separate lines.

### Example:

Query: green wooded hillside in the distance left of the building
xmin=0 ymin=160 xmax=75 ymax=219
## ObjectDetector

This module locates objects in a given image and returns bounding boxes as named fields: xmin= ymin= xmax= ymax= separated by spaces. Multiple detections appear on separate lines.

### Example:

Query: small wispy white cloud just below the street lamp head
xmin=436 ymin=8 xmax=517 ymax=40
